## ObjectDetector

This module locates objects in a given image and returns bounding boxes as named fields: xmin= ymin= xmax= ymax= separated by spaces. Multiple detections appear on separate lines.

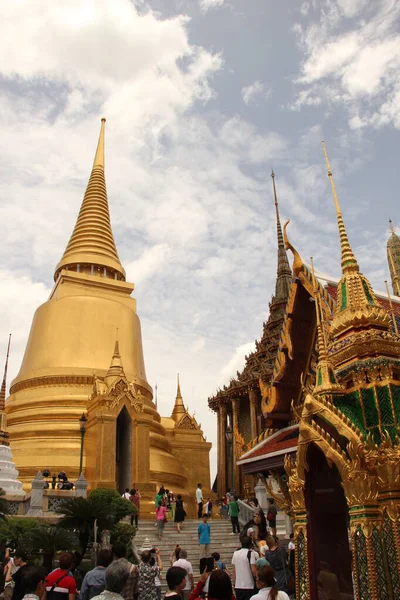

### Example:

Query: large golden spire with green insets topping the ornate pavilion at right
xmin=322 ymin=142 xmax=390 ymax=338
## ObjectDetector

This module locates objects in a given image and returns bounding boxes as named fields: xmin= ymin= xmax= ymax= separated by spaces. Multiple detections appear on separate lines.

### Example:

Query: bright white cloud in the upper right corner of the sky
xmin=291 ymin=0 xmax=400 ymax=129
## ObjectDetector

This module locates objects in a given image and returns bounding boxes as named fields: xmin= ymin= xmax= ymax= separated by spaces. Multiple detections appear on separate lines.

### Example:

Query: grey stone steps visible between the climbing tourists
xmin=135 ymin=519 xmax=287 ymax=595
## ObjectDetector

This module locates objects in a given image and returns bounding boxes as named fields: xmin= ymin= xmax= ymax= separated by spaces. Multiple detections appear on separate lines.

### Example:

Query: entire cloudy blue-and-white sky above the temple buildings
xmin=0 ymin=0 xmax=400 ymax=476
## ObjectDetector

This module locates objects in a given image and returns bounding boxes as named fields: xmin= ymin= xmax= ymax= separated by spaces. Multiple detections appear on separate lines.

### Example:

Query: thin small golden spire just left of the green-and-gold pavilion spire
xmin=310 ymin=256 xmax=344 ymax=395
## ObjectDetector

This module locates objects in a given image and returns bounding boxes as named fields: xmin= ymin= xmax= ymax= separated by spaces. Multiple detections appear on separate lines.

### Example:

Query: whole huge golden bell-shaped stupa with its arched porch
xmin=6 ymin=119 xmax=211 ymax=512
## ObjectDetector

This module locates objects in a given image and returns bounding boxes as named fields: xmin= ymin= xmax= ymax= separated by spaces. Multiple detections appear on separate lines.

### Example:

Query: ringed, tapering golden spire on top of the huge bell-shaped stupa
xmin=54 ymin=119 xmax=125 ymax=280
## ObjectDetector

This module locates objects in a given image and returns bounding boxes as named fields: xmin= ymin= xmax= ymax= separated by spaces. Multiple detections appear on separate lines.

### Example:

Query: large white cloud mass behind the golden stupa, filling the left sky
xmin=0 ymin=0 xmax=287 ymax=482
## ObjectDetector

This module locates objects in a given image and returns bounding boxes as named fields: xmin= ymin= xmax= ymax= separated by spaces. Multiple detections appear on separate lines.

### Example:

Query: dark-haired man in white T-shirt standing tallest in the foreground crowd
xmin=232 ymin=536 xmax=258 ymax=600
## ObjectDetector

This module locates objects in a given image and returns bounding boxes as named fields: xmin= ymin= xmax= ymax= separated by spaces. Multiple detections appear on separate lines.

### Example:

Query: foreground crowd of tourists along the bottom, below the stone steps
xmin=0 ymin=536 xmax=290 ymax=600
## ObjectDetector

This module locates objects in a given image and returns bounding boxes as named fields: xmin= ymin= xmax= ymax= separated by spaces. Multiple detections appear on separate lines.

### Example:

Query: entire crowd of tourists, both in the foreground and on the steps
xmin=3 ymin=484 xmax=294 ymax=600
